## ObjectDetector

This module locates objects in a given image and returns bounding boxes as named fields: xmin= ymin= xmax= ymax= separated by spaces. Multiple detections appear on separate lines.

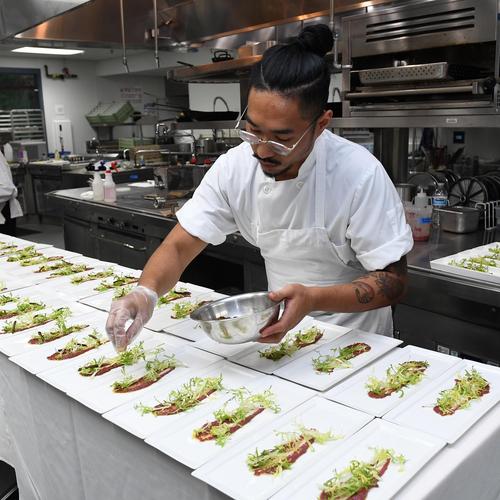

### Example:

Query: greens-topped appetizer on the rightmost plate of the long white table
xmin=433 ymin=368 xmax=490 ymax=417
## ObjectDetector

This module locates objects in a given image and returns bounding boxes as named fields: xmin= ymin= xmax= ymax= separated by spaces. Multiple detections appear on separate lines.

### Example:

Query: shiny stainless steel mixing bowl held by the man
xmin=191 ymin=292 xmax=280 ymax=344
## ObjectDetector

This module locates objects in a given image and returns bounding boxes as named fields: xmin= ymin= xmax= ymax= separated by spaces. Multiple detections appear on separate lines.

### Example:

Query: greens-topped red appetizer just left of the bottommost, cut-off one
xmin=247 ymin=425 xmax=338 ymax=476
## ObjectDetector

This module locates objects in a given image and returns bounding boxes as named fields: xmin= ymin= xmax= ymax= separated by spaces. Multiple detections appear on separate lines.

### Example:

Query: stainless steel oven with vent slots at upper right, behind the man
xmin=342 ymin=0 xmax=500 ymax=124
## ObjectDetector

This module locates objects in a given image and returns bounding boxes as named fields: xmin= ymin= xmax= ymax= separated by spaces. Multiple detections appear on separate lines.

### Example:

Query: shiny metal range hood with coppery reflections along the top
xmin=14 ymin=0 xmax=396 ymax=48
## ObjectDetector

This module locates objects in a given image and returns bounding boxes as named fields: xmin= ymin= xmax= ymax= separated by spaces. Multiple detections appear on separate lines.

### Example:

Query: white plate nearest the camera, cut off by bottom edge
xmin=272 ymin=419 xmax=445 ymax=500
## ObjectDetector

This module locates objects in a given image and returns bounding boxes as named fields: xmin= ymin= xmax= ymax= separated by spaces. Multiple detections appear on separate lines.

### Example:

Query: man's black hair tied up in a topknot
xmin=250 ymin=24 xmax=333 ymax=118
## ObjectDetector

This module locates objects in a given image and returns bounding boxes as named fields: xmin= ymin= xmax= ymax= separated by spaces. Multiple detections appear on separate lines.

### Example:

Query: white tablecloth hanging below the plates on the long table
xmin=0 ymin=235 xmax=500 ymax=500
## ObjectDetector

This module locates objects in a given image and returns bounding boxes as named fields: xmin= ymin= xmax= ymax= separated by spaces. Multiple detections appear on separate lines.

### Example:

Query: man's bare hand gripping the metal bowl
xmin=259 ymin=284 xmax=314 ymax=344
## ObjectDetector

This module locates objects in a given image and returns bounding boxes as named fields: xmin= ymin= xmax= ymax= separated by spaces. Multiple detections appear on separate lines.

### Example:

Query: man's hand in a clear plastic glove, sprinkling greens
xmin=106 ymin=285 xmax=158 ymax=352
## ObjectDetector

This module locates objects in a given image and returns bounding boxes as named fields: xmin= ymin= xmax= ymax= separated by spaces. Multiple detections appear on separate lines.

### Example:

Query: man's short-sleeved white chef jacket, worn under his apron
xmin=177 ymin=130 xmax=413 ymax=334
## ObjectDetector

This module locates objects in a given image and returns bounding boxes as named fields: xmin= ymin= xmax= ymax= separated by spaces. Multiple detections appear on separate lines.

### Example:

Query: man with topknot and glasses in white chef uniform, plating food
xmin=106 ymin=25 xmax=413 ymax=350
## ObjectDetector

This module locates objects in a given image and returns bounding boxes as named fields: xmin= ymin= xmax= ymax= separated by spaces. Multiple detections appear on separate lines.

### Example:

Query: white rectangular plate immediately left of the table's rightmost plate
xmin=324 ymin=345 xmax=460 ymax=417
